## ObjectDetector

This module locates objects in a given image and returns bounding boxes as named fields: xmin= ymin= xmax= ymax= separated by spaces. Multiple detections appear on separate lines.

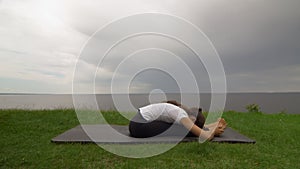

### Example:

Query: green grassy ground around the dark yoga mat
xmin=0 ymin=110 xmax=300 ymax=169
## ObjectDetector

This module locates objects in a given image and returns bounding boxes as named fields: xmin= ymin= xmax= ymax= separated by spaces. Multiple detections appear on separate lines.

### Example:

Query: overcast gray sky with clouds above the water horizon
xmin=0 ymin=0 xmax=300 ymax=93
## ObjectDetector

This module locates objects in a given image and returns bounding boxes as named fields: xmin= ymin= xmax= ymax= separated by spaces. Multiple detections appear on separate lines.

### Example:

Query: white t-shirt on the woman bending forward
xmin=139 ymin=103 xmax=188 ymax=124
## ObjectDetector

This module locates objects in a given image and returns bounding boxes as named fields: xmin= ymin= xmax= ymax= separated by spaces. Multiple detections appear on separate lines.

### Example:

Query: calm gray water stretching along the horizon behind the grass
xmin=0 ymin=93 xmax=300 ymax=114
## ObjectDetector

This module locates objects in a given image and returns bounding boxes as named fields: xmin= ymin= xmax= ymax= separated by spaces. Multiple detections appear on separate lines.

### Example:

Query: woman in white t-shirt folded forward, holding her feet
xmin=129 ymin=101 xmax=227 ymax=140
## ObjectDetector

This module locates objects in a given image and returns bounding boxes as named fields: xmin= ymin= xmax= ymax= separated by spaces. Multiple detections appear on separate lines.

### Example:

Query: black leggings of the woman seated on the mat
xmin=129 ymin=111 xmax=195 ymax=138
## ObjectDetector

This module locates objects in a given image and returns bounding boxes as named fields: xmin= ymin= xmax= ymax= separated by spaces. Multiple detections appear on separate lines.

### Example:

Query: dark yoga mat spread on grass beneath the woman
xmin=51 ymin=124 xmax=255 ymax=144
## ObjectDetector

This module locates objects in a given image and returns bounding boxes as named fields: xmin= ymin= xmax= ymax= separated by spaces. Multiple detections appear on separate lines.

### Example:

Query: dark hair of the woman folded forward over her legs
xmin=164 ymin=100 xmax=205 ymax=128
